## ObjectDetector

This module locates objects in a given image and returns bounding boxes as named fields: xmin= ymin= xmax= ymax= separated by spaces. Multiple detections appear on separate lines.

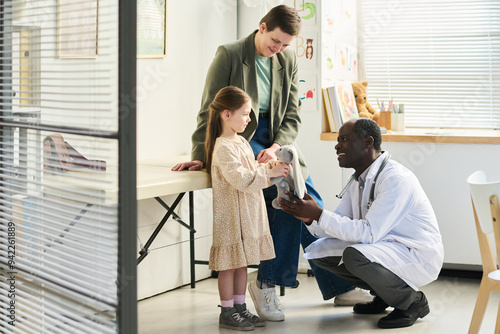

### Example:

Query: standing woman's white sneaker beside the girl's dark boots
xmin=248 ymin=279 xmax=285 ymax=321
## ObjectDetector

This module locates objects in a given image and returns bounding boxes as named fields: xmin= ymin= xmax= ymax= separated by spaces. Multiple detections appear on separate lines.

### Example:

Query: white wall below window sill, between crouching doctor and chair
xmin=383 ymin=143 xmax=500 ymax=269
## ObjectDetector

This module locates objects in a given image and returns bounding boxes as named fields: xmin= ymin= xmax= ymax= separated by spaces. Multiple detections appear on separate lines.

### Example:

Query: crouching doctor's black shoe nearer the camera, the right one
xmin=378 ymin=292 xmax=429 ymax=328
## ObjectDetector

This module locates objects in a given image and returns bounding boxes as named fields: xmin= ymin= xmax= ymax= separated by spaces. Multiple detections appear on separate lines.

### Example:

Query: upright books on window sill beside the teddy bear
xmin=325 ymin=81 xmax=359 ymax=132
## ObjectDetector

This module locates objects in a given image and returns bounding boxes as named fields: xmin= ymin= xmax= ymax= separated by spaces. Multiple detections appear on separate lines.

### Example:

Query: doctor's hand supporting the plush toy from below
xmin=279 ymin=191 xmax=323 ymax=225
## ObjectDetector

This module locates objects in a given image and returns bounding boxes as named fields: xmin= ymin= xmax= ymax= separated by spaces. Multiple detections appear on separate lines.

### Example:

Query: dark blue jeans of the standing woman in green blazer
xmin=250 ymin=118 xmax=354 ymax=300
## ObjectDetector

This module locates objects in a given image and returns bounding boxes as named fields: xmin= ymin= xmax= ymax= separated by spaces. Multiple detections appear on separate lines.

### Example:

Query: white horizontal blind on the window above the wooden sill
xmin=360 ymin=0 xmax=500 ymax=129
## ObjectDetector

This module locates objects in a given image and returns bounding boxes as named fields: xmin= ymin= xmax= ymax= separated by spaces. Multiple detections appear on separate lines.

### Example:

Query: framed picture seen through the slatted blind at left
xmin=57 ymin=0 xmax=99 ymax=58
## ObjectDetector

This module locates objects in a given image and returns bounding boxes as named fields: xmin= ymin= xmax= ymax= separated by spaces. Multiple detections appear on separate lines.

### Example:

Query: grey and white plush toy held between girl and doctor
xmin=271 ymin=145 xmax=306 ymax=209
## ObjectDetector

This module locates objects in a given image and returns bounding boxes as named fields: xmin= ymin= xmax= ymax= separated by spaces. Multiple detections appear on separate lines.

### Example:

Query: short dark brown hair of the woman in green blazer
xmin=259 ymin=5 xmax=302 ymax=36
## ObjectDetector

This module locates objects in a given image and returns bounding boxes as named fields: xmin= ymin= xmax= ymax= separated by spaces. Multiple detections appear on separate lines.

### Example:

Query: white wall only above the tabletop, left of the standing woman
xmin=137 ymin=0 xmax=236 ymax=160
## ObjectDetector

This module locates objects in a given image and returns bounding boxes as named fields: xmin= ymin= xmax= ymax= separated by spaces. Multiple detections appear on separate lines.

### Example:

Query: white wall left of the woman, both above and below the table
xmin=137 ymin=0 xmax=236 ymax=299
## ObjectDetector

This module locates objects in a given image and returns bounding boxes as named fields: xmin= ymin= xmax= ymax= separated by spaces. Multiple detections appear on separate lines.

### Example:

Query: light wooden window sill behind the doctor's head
xmin=320 ymin=128 xmax=500 ymax=144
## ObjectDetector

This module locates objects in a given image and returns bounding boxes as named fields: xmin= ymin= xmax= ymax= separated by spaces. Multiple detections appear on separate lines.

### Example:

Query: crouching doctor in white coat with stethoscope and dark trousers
xmin=280 ymin=118 xmax=444 ymax=328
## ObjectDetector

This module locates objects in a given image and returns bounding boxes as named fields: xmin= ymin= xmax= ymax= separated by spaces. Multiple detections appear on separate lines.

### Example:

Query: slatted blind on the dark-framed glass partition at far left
xmin=0 ymin=0 xmax=136 ymax=333
